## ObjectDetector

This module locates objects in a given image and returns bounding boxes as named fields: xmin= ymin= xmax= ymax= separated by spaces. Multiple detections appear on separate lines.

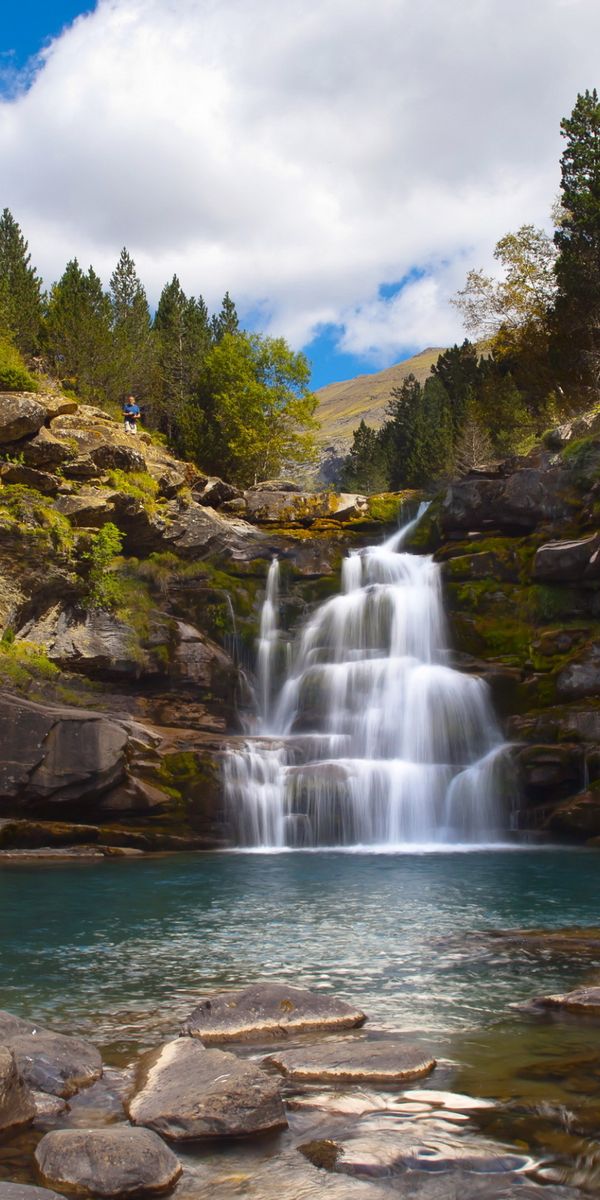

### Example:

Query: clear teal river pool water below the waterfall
xmin=0 ymin=848 xmax=600 ymax=1200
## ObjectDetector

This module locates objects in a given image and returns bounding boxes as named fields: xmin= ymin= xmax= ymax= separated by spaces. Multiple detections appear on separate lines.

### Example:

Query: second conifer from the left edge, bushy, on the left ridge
xmin=46 ymin=258 xmax=115 ymax=403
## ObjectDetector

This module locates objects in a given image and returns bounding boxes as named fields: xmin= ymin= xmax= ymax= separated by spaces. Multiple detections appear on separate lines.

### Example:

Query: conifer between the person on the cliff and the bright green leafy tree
xmin=152 ymin=275 xmax=211 ymax=450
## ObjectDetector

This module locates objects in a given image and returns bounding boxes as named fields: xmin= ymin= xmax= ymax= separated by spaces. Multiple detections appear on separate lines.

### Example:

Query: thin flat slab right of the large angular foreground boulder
xmin=264 ymin=1042 xmax=436 ymax=1084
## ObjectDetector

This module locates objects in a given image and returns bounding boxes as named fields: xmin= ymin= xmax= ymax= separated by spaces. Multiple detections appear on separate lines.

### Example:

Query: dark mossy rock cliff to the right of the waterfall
xmin=410 ymin=414 xmax=600 ymax=841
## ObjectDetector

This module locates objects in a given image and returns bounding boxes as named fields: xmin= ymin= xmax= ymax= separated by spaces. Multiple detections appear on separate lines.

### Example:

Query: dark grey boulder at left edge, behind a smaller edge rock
xmin=0 ymin=1010 xmax=102 ymax=1097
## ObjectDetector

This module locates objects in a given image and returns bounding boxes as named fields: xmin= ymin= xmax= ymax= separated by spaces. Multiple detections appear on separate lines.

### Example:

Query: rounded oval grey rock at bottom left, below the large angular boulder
xmin=35 ymin=1126 xmax=181 ymax=1198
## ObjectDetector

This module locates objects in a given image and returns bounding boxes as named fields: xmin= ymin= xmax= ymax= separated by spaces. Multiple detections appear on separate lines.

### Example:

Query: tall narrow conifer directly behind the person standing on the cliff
xmin=109 ymin=246 xmax=155 ymax=402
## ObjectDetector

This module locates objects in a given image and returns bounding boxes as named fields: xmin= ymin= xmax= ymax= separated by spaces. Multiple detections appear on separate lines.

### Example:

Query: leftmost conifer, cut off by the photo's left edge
xmin=0 ymin=209 xmax=42 ymax=354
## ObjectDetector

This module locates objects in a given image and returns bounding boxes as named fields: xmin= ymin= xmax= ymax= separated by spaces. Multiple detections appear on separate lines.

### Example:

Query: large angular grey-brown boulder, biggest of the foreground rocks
xmin=127 ymin=1038 xmax=287 ymax=1141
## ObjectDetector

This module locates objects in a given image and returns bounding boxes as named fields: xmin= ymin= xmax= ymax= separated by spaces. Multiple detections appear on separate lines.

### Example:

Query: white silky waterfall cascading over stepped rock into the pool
xmin=226 ymin=511 xmax=506 ymax=850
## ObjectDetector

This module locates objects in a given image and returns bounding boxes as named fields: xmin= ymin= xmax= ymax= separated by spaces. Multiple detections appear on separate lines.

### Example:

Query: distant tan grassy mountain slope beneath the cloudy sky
xmin=317 ymin=347 xmax=443 ymax=454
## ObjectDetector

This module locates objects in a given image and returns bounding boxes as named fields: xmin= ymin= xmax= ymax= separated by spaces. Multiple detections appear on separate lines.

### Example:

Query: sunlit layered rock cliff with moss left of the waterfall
xmin=0 ymin=394 xmax=408 ymax=853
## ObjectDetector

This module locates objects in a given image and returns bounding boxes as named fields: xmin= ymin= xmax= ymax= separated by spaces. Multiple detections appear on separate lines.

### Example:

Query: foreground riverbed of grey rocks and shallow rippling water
xmin=0 ymin=974 xmax=600 ymax=1200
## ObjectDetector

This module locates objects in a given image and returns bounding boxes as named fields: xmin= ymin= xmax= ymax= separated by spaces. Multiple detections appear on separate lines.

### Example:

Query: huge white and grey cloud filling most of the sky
xmin=0 ymin=0 xmax=600 ymax=362
